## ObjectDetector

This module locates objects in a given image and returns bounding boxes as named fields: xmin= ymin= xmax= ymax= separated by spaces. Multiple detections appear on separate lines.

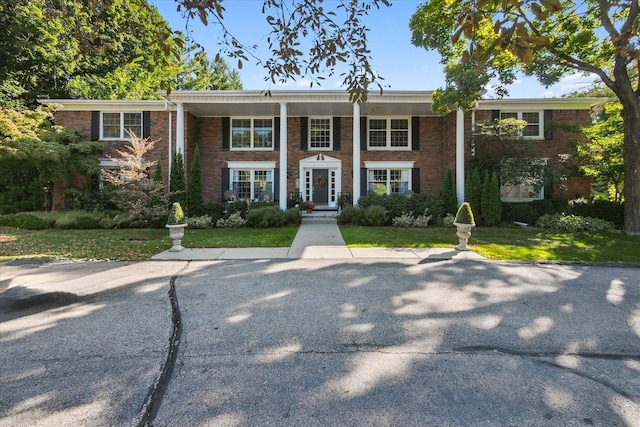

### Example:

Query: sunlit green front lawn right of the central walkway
xmin=340 ymin=226 xmax=640 ymax=263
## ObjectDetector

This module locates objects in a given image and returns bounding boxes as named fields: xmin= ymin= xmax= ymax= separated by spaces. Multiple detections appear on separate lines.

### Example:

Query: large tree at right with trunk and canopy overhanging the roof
xmin=410 ymin=0 xmax=640 ymax=235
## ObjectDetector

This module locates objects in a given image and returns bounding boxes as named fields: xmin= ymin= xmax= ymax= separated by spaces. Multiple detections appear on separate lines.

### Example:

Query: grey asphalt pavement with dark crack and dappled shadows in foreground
xmin=0 ymin=259 xmax=640 ymax=427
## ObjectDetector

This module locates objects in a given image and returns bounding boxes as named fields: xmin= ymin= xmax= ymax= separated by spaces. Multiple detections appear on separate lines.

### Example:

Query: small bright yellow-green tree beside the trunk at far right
xmin=576 ymin=102 xmax=624 ymax=203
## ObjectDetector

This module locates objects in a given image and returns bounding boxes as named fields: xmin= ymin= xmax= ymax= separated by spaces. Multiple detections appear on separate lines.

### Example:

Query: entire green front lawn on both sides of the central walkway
xmin=0 ymin=226 xmax=640 ymax=264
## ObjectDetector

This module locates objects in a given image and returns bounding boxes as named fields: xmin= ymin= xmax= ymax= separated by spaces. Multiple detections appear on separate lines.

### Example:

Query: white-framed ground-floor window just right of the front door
xmin=365 ymin=162 xmax=413 ymax=195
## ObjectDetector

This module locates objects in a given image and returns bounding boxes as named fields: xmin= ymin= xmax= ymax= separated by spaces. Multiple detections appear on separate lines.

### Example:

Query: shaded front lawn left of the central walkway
xmin=0 ymin=227 xmax=298 ymax=261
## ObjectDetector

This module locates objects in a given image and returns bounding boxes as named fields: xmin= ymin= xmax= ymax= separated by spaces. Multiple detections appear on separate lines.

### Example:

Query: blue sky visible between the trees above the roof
xmin=149 ymin=0 xmax=592 ymax=98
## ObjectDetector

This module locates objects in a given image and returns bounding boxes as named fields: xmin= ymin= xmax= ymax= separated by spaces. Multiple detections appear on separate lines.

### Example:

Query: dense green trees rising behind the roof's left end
xmin=0 ymin=0 xmax=183 ymax=109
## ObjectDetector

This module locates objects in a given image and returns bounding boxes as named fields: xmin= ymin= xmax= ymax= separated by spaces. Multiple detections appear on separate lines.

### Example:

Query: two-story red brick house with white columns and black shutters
xmin=42 ymin=90 xmax=594 ymax=209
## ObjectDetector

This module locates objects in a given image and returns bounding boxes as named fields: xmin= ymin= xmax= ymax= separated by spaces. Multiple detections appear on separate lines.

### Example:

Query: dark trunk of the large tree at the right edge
xmin=620 ymin=93 xmax=640 ymax=236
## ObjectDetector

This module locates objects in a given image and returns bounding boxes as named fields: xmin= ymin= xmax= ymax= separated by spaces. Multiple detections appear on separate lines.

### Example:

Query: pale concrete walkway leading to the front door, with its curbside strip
xmin=151 ymin=212 xmax=485 ymax=261
